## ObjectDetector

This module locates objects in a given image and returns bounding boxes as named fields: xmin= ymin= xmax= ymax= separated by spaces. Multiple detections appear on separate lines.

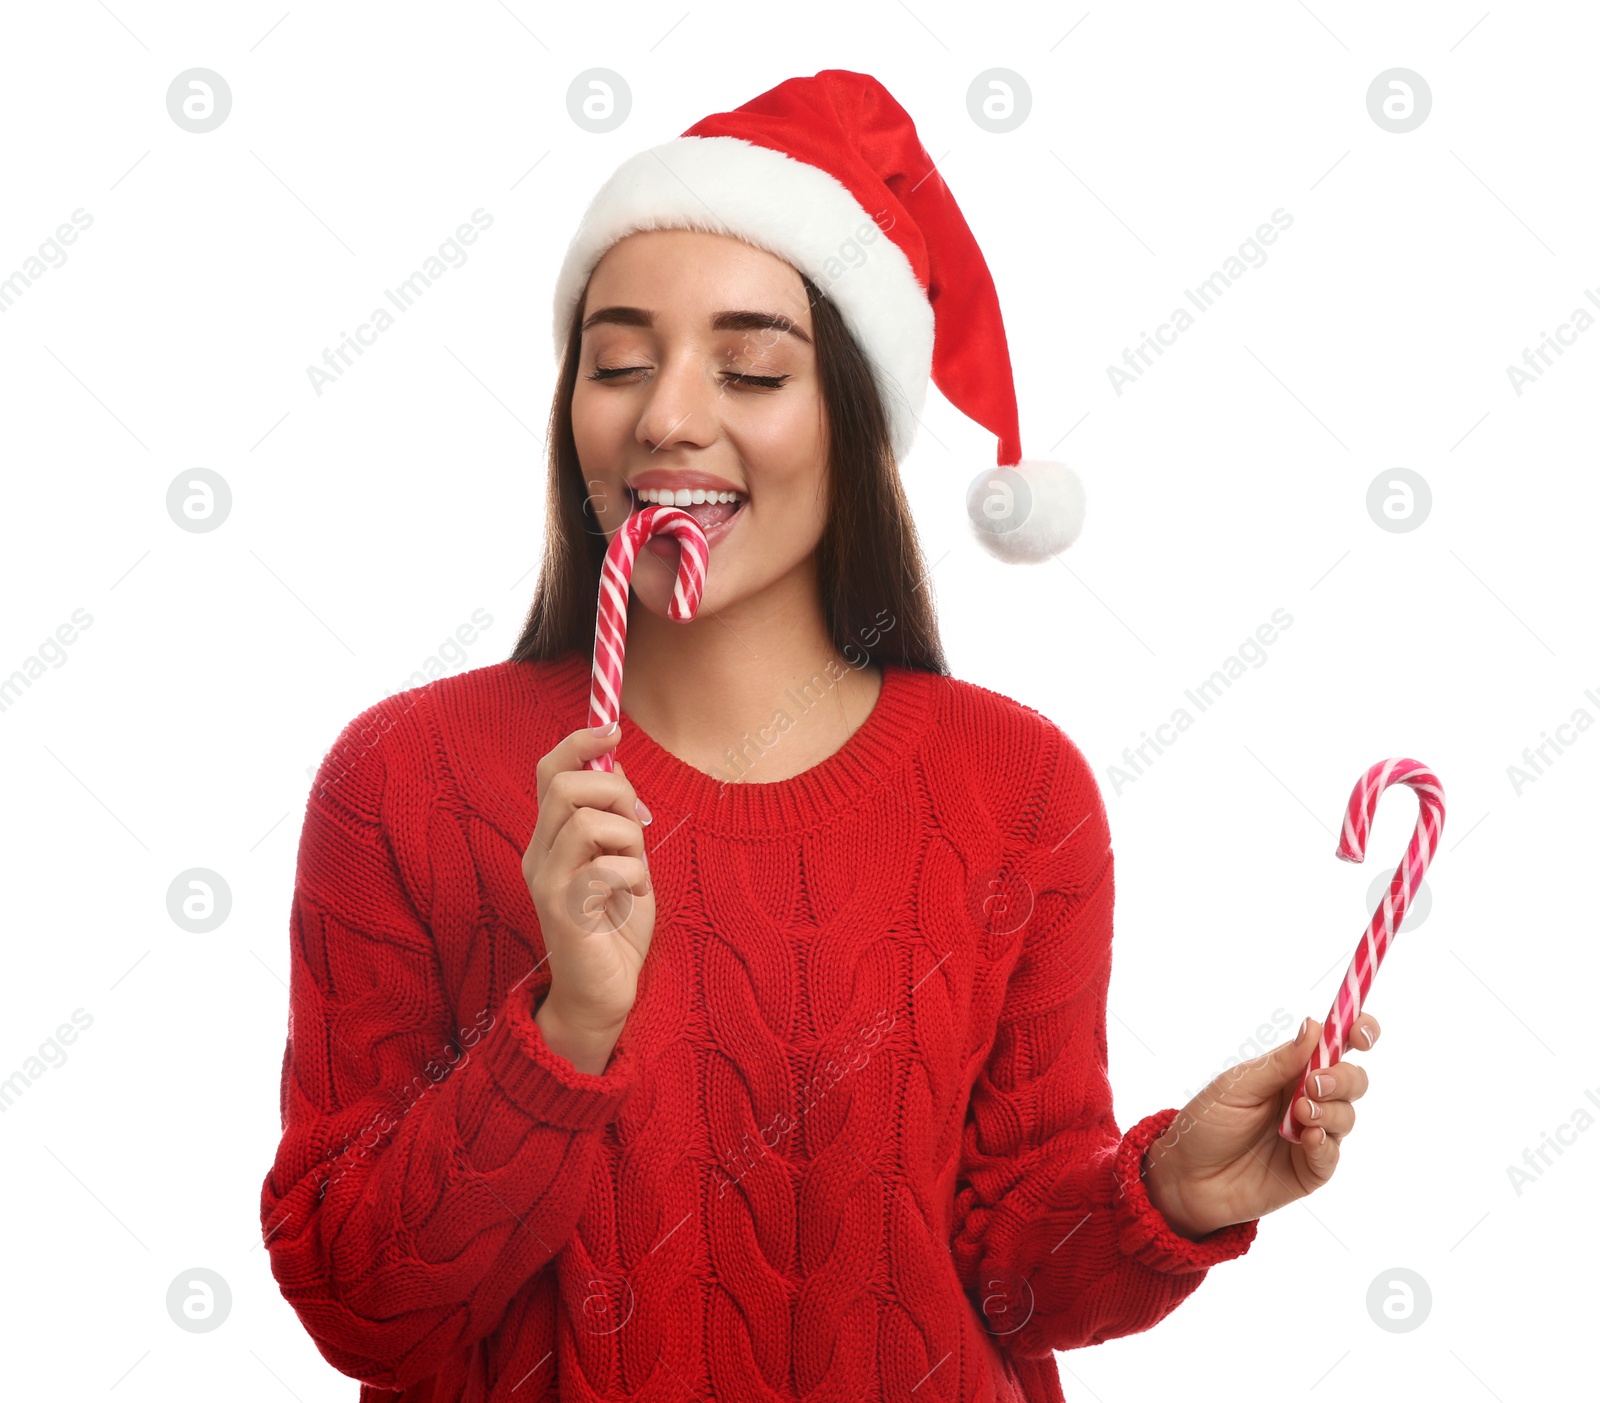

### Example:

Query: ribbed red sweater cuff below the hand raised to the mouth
xmin=480 ymin=976 xmax=637 ymax=1129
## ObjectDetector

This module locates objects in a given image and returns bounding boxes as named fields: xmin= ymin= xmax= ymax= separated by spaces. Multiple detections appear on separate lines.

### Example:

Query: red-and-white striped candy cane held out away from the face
xmin=1278 ymin=760 xmax=1445 ymax=1144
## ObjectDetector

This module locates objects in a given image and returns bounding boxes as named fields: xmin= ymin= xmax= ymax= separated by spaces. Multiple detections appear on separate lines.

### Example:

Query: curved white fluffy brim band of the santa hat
xmin=555 ymin=136 xmax=933 ymax=459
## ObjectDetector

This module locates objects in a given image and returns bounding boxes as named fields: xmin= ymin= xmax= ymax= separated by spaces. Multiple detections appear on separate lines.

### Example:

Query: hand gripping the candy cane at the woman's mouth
xmin=522 ymin=726 xmax=656 ymax=1072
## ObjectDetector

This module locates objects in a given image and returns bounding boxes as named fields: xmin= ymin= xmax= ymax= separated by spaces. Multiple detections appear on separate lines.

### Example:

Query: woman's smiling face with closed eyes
xmin=573 ymin=229 xmax=827 ymax=614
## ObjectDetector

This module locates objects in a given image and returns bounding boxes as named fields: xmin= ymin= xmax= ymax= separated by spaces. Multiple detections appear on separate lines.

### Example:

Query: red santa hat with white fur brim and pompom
xmin=555 ymin=69 xmax=1083 ymax=562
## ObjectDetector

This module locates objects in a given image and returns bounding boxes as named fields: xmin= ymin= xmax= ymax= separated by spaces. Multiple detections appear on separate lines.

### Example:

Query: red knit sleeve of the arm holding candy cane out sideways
xmin=952 ymin=716 xmax=1259 ymax=1358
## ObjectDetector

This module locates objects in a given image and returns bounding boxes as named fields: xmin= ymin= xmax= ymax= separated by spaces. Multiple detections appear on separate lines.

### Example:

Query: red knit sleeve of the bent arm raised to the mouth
xmin=261 ymin=702 xmax=635 ymax=1390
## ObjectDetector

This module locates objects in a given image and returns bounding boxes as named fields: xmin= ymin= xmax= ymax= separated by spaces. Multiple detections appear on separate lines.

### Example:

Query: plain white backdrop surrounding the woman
xmin=0 ymin=0 xmax=1600 ymax=1403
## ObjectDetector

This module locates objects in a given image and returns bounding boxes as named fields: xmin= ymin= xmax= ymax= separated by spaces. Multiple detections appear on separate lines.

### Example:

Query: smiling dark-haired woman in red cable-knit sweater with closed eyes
xmin=261 ymin=72 xmax=1378 ymax=1403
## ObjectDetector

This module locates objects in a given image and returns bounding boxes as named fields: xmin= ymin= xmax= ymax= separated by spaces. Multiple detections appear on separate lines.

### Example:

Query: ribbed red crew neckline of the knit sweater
xmin=540 ymin=653 xmax=933 ymax=841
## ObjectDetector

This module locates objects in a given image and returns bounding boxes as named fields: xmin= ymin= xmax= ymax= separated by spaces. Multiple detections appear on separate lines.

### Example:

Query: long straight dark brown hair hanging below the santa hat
xmin=510 ymin=274 xmax=949 ymax=675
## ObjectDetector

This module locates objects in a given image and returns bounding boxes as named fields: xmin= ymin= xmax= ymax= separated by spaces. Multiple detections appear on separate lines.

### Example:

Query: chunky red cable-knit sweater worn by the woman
xmin=261 ymin=654 xmax=1256 ymax=1403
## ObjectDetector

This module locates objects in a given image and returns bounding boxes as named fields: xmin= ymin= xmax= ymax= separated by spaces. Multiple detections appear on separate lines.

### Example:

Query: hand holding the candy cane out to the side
xmin=1146 ymin=1013 xmax=1379 ymax=1238
